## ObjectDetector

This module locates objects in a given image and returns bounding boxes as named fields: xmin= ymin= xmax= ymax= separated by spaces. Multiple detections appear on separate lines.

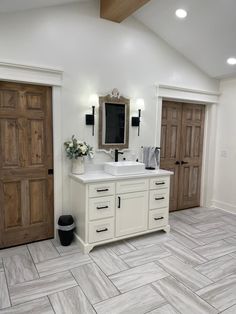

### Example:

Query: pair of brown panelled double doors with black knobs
xmin=161 ymin=101 xmax=205 ymax=211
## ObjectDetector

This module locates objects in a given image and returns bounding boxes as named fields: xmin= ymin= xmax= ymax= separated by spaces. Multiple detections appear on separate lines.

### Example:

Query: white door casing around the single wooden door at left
xmin=0 ymin=62 xmax=63 ymax=236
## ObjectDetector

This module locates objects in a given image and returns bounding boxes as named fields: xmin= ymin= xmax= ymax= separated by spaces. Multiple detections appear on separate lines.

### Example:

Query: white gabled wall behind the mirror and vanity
xmin=0 ymin=1 xmax=218 ymax=208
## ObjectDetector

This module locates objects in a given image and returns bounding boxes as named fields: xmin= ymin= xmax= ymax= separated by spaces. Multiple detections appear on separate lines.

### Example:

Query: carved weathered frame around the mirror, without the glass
xmin=98 ymin=94 xmax=130 ymax=150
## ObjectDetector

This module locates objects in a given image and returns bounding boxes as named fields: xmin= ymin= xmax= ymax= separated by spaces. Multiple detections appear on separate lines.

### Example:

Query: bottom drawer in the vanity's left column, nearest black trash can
xmin=89 ymin=219 xmax=114 ymax=243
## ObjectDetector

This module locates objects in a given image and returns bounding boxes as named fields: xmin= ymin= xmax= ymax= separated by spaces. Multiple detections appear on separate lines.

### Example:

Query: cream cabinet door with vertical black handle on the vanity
xmin=116 ymin=192 xmax=148 ymax=237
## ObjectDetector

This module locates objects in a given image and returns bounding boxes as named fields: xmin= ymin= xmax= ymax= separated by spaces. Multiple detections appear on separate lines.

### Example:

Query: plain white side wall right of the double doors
xmin=213 ymin=78 xmax=236 ymax=213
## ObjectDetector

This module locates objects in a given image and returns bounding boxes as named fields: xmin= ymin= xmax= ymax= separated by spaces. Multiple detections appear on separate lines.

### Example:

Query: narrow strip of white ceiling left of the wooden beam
xmin=0 ymin=0 xmax=85 ymax=12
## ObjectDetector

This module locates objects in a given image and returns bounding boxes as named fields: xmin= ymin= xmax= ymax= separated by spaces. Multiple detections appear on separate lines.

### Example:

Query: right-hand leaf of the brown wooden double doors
xmin=178 ymin=104 xmax=205 ymax=209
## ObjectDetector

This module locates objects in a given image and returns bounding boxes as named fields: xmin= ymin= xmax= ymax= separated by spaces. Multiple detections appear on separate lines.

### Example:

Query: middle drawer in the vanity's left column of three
xmin=89 ymin=196 xmax=115 ymax=220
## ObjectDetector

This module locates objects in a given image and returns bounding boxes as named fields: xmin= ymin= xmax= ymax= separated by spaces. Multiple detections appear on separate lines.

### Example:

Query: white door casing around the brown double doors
xmin=155 ymin=85 xmax=220 ymax=207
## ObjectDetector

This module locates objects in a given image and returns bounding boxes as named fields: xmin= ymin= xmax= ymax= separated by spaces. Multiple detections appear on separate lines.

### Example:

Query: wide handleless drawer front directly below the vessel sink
xmin=116 ymin=179 xmax=148 ymax=194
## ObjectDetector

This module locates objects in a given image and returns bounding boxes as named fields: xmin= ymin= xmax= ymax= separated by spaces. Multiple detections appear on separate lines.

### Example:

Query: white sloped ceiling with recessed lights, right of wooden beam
xmin=135 ymin=0 xmax=236 ymax=77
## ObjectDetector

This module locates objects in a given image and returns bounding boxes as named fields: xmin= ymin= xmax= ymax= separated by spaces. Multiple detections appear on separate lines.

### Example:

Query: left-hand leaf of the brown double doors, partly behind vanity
xmin=160 ymin=101 xmax=182 ymax=211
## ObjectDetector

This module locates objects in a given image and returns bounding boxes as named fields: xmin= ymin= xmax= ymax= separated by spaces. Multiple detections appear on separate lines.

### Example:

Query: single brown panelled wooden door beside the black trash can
xmin=0 ymin=82 xmax=54 ymax=248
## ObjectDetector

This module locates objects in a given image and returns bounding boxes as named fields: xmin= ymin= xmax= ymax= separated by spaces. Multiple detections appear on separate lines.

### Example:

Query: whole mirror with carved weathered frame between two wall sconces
xmin=98 ymin=95 xmax=130 ymax=150
